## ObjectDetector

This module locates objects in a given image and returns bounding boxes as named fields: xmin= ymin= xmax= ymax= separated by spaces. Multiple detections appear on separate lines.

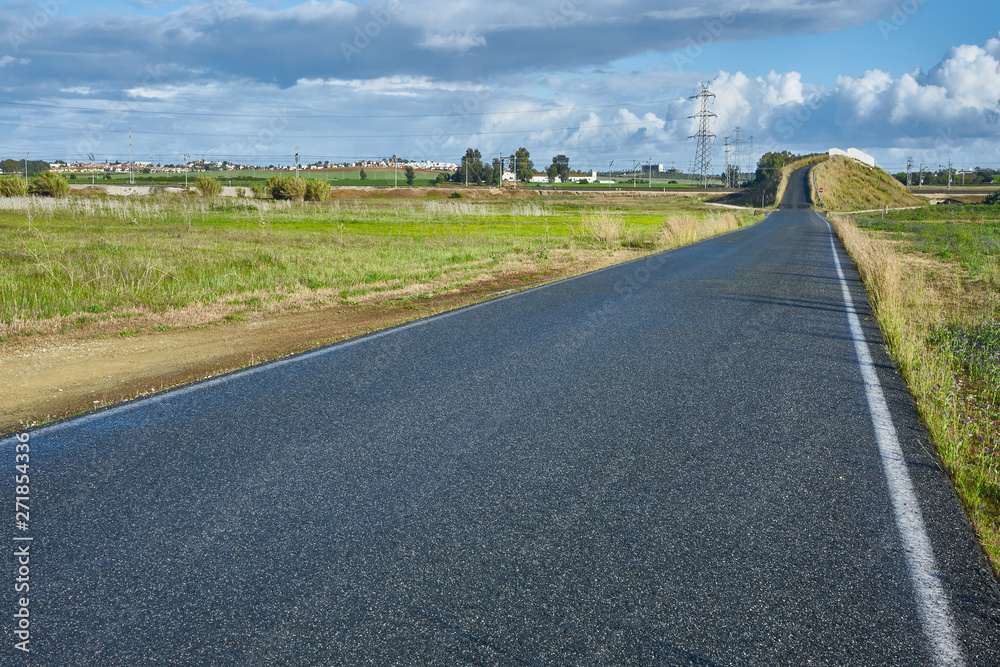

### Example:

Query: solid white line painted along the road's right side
xmin=827 ymin=222 xmax=965 ymax=665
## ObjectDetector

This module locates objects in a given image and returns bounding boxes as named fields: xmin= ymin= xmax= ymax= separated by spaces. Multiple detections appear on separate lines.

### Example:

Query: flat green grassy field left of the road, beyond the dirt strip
xmin=0 ymin=193 xmax=758 ymax=340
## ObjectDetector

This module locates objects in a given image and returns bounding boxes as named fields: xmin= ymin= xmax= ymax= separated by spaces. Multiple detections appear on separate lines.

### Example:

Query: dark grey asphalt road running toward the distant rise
xmin=0 ymin=173 xmax=1000 ymax=665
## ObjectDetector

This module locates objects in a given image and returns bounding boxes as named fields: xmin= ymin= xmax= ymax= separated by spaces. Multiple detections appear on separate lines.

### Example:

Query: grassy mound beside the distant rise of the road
xmin=811 ymin=155 xmax=927 ymax=211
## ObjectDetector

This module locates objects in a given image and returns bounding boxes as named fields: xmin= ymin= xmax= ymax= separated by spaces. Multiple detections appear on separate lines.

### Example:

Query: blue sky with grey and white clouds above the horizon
xmin=0 ymin=0 xmax=1000 ymax=170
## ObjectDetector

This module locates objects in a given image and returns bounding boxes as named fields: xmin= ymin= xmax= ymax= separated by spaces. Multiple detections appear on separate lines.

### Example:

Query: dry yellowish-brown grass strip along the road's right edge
xmin=832 ymin=217 xmax=1000 ymax=574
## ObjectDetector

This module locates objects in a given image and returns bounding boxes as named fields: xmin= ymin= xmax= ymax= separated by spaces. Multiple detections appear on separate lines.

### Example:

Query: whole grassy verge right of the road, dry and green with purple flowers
xmin=833 ymin=206 xmax=1000 ymax=574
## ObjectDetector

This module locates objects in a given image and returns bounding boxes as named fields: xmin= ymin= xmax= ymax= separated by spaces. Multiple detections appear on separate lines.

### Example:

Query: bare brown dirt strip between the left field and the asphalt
xmin=0 ymin=252 xmax=635 ymax=433
